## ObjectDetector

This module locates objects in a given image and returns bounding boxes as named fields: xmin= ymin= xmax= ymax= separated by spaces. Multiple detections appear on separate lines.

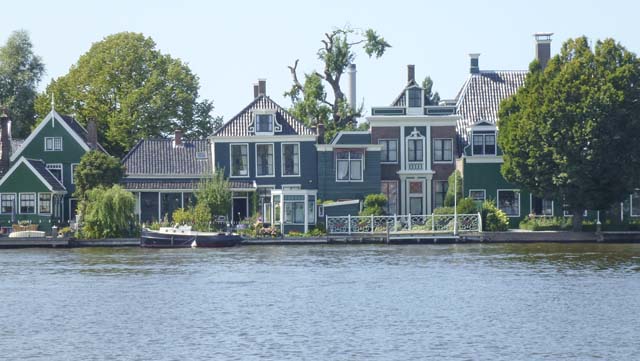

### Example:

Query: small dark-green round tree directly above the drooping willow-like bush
xmin=73 ymin=150 xmax=124 ymax=200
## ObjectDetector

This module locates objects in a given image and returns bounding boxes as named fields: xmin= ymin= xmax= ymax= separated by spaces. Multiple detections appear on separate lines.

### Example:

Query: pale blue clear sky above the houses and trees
xmin=0 ymin=0 xmax=640 ymax=120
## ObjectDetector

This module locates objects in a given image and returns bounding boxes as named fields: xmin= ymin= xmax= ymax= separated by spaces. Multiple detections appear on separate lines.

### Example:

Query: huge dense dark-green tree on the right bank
xmin=498 ymin=37 xmax=640 ymax=230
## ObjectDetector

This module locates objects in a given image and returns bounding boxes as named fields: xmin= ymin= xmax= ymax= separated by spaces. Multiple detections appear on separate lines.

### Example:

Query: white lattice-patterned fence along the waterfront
xmin=326 ymin=213 xmax=482 ymax=235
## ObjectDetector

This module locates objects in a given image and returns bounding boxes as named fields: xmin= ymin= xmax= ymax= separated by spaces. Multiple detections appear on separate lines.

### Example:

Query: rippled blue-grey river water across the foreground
xmin=0 ymin=244 xmax=640 ymax=360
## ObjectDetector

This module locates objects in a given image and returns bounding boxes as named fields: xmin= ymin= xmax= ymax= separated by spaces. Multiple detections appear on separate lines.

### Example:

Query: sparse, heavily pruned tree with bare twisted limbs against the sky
xmin=285 ymin=27 xmax=391 ymax=142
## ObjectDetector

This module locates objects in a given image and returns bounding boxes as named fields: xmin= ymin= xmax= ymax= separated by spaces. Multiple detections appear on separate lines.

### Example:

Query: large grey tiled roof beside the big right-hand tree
xmin=456 ymin=71 xmax=527 ymax=146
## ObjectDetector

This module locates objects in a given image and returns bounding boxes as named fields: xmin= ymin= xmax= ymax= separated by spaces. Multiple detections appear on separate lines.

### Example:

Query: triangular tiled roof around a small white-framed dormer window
xmin=213 ymin=95 xmax=315 ymax=137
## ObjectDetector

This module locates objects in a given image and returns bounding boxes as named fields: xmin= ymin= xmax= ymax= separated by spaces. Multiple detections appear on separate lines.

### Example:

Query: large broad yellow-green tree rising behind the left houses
xmin=36 ymin=32 xmax=221 ymax=157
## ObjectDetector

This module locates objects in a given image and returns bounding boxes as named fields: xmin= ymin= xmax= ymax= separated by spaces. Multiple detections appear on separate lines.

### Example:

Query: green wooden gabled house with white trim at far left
xmin=0 ymin=110 xmax=104 ymax=231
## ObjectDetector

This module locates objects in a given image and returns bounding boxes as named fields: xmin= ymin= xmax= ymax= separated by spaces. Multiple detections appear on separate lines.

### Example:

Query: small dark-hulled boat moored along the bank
xmin=140 ymin=227 xmax=242 ymax=248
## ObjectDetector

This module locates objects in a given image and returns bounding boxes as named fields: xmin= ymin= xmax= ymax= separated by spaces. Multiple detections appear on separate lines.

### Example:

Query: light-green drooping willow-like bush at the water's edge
xmin=82 ymin=185 xmax=137 ymax=238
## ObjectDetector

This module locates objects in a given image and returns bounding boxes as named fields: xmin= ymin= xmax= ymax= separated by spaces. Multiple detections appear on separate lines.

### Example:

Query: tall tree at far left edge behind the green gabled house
xmin=0 ymin=30 xmax=45 ymax=138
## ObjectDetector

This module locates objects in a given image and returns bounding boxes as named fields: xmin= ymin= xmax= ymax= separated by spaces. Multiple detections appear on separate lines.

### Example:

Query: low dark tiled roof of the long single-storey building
xmin=122 ymin=139 xmax=213 ymax=178
